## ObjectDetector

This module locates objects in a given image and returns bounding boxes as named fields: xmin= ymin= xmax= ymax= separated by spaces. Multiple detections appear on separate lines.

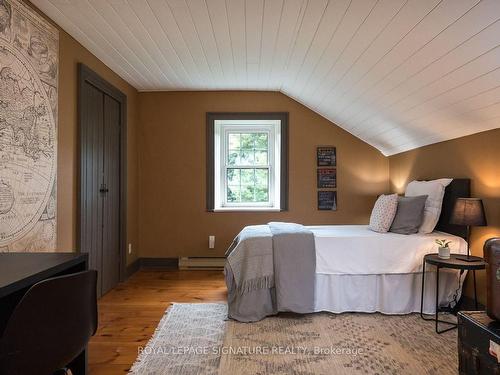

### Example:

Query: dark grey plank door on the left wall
xmin=79 ymin=65 xmax=123 ymax=296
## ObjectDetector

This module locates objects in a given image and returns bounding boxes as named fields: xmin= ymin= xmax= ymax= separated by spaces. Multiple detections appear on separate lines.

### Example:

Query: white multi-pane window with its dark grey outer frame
xmin=207 ymin=114 xmax=287 ymax=211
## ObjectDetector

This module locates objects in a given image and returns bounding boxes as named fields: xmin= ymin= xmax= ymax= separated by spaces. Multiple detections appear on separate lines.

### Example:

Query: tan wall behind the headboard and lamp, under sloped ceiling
xmin=389 ymin=129 xmax=500 ymax=303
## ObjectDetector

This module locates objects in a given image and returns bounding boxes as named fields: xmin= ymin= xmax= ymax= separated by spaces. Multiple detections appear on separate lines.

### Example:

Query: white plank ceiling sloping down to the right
xmin=36 ymin=0 xmax=500 ymax=155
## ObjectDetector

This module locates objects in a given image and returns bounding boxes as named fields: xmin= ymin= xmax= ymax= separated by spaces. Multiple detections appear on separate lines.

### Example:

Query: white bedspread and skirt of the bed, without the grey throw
xmin=308 ymin=225 xmax=467 ymax=314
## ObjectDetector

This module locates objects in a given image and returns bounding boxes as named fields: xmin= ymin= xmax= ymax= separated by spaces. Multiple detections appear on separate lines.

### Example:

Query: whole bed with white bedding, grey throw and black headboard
xmin=225 ymin=179 xmax=470 ymax=322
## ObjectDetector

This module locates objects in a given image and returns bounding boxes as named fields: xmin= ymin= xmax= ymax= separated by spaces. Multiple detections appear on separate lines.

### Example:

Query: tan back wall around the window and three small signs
xmin=139 ymin=92 xmax=389 ymax=257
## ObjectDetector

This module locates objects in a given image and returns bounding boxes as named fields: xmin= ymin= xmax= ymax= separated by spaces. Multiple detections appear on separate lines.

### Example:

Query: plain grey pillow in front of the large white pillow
xmin=389 ymin=195 xmax=427 ymax=234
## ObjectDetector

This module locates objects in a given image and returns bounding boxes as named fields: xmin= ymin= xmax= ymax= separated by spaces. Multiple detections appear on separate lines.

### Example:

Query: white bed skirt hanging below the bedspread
xmin=315 ymin=269 xmax=466 ymax=314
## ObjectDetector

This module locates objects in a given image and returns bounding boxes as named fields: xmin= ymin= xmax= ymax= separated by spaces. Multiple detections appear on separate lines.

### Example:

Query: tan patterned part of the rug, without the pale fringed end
xmin=220 ymin=313 xmax=458 ymax=375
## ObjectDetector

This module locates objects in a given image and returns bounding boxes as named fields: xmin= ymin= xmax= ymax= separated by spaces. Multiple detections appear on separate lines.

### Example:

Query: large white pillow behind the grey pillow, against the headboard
xmin=405 ymin=178 xmax=453 ymax=233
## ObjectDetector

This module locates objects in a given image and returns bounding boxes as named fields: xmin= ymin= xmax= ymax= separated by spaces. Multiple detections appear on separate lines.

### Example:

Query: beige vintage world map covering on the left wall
xmin=0 ymin=0 xmax=59 ymax=252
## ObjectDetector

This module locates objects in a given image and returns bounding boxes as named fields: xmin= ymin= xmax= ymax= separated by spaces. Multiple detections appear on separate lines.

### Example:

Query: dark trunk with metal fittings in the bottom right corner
xmin=458 ymin=311 xmax=500 ymax=375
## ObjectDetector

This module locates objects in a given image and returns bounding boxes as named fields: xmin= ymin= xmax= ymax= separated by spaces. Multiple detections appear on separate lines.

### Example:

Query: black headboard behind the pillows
xmin=435 ymin=178 xmax=470 ymax=238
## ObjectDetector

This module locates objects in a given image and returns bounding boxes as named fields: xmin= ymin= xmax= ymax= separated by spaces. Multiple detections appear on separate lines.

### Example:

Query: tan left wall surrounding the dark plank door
xmin=28 ymin=3 xmax=138 ymax=263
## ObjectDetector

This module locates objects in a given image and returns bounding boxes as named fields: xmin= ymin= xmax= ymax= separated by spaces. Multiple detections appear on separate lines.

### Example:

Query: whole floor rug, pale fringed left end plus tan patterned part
xmin=131 ymin=303 xmax=458 ymax=375
